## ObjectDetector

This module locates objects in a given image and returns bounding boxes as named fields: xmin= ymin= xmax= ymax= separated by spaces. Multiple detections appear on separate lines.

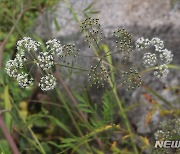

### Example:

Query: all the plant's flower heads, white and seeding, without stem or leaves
xmin=6 ymin=18 xmax=173 ymax=91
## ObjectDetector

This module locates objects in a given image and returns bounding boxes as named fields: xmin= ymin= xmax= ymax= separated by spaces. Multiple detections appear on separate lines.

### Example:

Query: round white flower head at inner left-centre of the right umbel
xmin=143 ymin=53 xmax=157 ymax=67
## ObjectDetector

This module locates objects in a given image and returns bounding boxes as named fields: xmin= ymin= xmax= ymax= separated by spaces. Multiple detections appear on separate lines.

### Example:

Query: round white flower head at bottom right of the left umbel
xmin=39 ymin=74 xmax=57 ymax=91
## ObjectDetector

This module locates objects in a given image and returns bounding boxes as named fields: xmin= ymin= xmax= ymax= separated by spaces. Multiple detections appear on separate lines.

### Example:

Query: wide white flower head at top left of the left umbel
xmin=17 ymin=37 xmax=41 ymax=51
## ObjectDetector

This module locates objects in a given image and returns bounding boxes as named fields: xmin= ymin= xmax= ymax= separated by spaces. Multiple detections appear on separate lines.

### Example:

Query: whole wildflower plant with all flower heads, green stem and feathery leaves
xmin=3 ymin=12 xmax=179 ymax=154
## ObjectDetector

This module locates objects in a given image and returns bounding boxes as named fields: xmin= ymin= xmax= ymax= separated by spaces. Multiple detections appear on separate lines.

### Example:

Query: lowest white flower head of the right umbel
xmin=154 ymin=64 xmax=169 ymax=78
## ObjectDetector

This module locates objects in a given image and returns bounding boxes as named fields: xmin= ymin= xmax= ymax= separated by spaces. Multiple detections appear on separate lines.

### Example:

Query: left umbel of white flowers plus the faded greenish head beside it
xmin=6 ymin=37 xmax=79 ymax=91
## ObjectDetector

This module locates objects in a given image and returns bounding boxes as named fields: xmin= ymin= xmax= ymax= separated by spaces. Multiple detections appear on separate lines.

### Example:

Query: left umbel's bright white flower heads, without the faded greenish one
xmin=5 ymin=37 xmax=66 ymax=91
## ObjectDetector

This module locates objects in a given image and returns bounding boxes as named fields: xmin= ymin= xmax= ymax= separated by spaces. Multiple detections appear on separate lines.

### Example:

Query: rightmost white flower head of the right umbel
xmin=160 ymin=49 xmax=173 ymax=64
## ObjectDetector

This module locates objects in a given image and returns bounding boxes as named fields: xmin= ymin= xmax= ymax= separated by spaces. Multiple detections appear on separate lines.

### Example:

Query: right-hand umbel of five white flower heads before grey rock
xmin=136 ymin=37 xmax=173 ymax=78
